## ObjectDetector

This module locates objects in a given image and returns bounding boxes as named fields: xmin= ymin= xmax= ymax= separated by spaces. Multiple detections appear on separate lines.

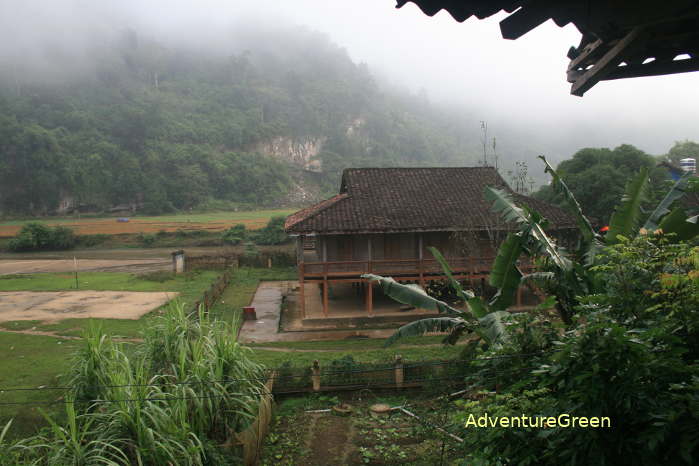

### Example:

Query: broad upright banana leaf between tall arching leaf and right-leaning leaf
xmin=606 ymin=168 xmax=648 ymax=244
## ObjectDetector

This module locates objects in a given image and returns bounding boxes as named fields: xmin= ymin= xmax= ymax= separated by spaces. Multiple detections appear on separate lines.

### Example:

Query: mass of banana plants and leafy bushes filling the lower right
xmin=378 ymin=157 xmax=699 ymax=465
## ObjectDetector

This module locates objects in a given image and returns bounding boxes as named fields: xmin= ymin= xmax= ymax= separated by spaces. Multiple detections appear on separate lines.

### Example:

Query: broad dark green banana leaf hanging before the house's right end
xmin=489 ymin=233 xmax=525 ymax=311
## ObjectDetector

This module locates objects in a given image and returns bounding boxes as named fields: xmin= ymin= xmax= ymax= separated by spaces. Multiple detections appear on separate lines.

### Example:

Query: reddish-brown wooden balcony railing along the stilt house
xmin=302 ymin=257 xmax=529 ymax=278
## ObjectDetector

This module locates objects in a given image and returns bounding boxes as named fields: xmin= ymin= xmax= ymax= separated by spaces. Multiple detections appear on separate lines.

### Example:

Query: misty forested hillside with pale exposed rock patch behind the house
xmin=0 ymin=25 xmax=479 ymax=214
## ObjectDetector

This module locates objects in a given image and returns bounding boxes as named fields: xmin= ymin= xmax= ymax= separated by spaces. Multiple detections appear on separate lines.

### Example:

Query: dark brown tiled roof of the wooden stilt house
xmin=285 ymin=167 xmax=575 ymax=234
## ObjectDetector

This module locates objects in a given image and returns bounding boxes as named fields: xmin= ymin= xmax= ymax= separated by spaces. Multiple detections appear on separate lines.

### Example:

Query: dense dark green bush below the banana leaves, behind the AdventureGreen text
xmin=456 ymin=235 xmax=699 ymax=465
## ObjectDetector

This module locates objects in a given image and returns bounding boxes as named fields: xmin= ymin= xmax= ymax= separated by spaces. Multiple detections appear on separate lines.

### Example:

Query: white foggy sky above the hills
xmin=0 ymin=0 xmax=699 ymax=165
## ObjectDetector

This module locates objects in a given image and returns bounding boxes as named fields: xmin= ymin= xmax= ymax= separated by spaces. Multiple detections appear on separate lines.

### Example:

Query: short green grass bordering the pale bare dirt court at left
xmin=0 ymin=271 xmax=219 ymax=338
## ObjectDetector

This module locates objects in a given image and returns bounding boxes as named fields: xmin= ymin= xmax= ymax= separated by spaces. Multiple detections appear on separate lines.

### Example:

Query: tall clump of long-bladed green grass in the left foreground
xmin=10 ymin=304 xmax=264 ymax=466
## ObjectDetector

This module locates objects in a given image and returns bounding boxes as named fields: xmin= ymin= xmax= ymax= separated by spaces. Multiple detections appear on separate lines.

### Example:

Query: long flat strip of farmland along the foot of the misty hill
xmin=0 ymin=209 xmax=295 ymax=238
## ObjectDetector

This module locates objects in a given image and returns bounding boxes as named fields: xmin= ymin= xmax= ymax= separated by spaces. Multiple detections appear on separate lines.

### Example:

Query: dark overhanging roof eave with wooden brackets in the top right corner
xmin=397 ymin=0 xmax=699 ymax=96
